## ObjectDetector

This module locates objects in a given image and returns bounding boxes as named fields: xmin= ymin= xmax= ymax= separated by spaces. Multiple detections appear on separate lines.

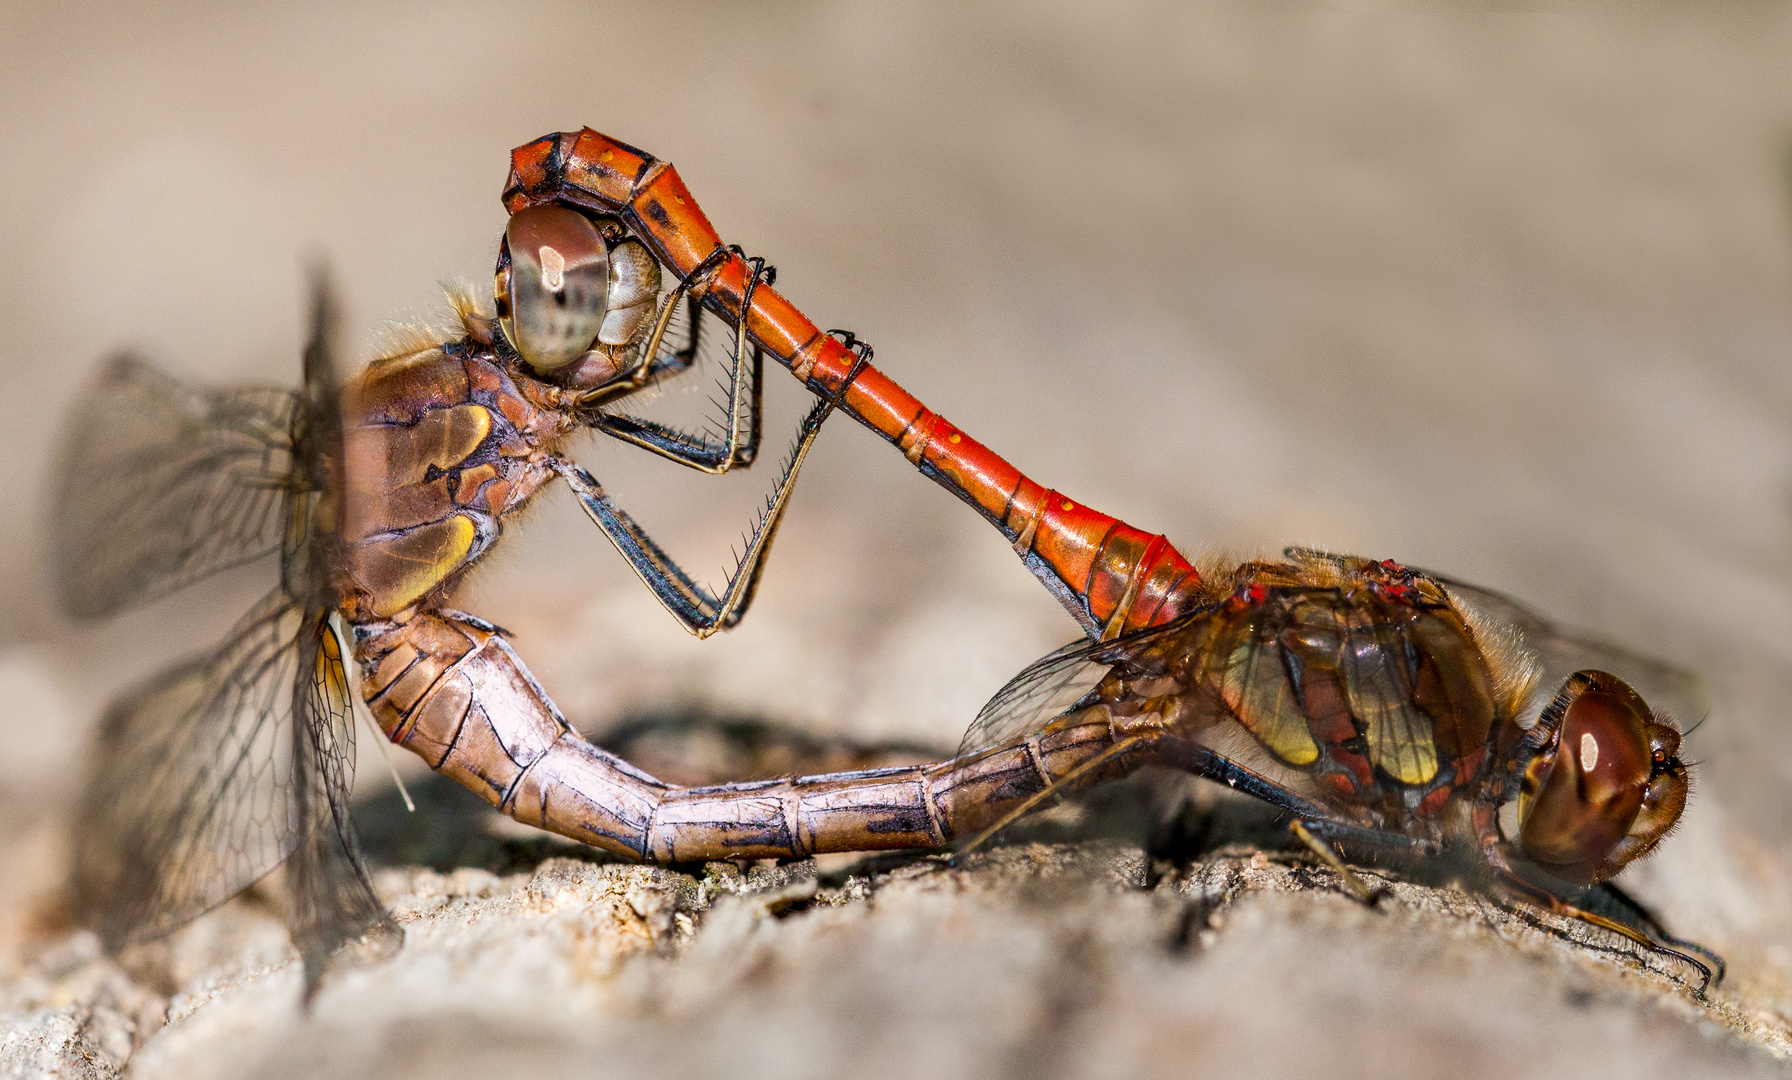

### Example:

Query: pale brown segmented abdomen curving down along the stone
xmin=355 ymin=611 xmax=1136 ymax=861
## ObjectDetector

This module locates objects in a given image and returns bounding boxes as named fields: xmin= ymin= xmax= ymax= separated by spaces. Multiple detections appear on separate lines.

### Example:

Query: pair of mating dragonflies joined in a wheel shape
xmin=56 ymin=129 xmax=1722 ymax=990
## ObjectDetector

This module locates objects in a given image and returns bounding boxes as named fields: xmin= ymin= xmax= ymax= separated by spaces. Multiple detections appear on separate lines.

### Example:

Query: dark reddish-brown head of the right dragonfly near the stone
xmin=1518 ymin=672 xmax=1688 ymax=885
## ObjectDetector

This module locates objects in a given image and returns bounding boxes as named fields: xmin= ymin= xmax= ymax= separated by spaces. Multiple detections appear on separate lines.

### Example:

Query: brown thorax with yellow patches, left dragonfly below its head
xmin=342 ymin=349 xmax=559 ymax=618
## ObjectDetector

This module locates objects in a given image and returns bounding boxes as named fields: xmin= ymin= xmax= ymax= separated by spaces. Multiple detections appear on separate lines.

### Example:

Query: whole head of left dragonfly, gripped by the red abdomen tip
xmin=493 ymin=204 xmax=659 ymax=389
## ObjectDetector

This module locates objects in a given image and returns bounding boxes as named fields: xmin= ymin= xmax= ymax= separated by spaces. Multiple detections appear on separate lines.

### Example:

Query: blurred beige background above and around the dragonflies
xmin=0 ymin=2 xmax=1792 ymax=1074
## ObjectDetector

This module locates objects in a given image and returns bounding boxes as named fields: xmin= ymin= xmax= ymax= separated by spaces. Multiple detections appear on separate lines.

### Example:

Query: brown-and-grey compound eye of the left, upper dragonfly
xmin=493 ymin=206 xmax=609 ymax=373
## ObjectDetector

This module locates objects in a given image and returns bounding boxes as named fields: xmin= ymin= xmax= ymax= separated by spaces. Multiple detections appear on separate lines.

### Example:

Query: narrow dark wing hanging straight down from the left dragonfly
xmin=287 ymin=620 xmax=403 ymax=994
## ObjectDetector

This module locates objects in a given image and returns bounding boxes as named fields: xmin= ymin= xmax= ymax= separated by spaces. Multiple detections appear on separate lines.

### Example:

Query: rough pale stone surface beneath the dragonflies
xmin=0 ymin=784 xmax=1792 ymax=1080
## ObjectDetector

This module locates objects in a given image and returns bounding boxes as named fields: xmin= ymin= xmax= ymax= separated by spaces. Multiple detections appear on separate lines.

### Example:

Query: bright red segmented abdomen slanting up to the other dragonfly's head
xmin=504 ymin=127 xmax=1201 ymax=636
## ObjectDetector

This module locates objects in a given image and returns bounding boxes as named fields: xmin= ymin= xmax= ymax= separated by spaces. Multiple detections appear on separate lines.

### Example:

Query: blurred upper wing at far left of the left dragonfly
xmin=52 ymin=356 xmax=297 ymax=618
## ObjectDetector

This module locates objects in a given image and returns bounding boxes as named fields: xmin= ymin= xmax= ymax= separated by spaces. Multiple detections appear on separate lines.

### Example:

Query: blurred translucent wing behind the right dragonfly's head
xmin=1426 ymin=571 xmax=1711 ymax=725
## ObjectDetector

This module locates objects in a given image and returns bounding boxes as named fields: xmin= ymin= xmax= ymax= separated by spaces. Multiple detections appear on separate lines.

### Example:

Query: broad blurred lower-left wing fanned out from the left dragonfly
xmin=75 ymin=593 xmax=303 ymax=947
